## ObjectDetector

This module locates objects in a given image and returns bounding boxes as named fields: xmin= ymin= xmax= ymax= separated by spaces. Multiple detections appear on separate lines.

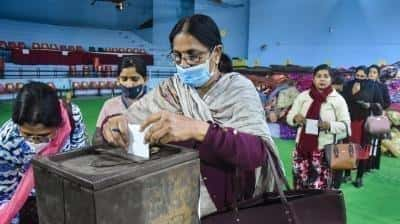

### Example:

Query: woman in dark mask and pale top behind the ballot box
xmin=93 ymin=56 xmax=147 ymax=144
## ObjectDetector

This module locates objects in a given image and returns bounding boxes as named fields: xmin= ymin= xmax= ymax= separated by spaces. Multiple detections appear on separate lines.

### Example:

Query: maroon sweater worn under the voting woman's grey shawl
xmin=175 ymin=124 xmax=266 ymax=210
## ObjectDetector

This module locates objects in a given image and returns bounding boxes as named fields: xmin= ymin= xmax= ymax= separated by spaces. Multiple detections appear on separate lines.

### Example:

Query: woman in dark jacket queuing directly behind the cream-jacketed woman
xmin=343 ymin=66 xmax=383 ymax=188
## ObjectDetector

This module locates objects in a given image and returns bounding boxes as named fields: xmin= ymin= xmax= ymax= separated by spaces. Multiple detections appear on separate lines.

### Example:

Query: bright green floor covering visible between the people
xmin=0 ymin=98 xmax=400 ymax=224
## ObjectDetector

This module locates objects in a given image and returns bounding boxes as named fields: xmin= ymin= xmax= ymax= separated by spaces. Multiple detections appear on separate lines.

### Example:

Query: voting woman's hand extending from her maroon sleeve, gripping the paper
xmin=141 ymin=111 xmax=209 ymax=144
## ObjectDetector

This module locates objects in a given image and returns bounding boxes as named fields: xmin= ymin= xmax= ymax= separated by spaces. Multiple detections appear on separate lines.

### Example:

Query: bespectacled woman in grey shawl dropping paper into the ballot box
xmin=102 ymin=15 xmax=278 ymax=217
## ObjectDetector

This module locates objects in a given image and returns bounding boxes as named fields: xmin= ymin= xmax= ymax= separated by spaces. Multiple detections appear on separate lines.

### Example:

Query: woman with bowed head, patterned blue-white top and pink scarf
xmin=0 ymin=82 xmax=87 ymax=223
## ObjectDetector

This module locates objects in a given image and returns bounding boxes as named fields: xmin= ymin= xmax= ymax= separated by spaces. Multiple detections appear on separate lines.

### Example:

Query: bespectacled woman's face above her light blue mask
xmin=172 ymin=33 xmax=222 ymax=71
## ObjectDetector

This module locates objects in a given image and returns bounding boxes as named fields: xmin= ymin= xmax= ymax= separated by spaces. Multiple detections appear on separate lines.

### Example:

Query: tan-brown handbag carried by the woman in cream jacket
xmin=324 ymin=122 xmax=361 ymax=170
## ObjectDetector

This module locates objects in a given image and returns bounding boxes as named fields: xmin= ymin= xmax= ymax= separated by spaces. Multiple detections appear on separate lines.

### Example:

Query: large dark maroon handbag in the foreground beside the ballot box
xmin=201 ymin=148 xmax=346 ymax=224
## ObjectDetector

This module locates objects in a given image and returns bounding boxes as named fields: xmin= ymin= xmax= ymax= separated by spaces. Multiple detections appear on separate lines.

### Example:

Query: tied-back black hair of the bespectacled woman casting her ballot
xmin=169 ymin=14 xmax=232 ymax=73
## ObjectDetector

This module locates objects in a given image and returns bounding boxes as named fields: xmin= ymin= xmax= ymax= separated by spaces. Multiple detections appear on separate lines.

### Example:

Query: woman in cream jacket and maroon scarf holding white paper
xmin=287 ymin=64 xmax=350 ymax=189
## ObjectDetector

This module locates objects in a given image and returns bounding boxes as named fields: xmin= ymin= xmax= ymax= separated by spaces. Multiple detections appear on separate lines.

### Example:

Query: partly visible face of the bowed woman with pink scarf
xmin=20 ymin=123 xmax=57 ymax=144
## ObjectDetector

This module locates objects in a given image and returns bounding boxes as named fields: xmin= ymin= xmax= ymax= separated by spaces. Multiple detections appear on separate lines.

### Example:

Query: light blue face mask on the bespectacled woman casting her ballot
xmin=176 ymin=59 xmax=212 ymax=88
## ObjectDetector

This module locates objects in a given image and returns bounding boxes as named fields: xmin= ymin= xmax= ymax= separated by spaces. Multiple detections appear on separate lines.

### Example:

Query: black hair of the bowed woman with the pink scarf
xmin=12 ymin=82 xmax=62 ymax=127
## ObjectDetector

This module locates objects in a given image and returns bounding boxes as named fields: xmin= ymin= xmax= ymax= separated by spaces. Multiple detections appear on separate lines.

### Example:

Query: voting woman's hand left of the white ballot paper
xmin=102 ymin=115 xmax=129 ymax=148
